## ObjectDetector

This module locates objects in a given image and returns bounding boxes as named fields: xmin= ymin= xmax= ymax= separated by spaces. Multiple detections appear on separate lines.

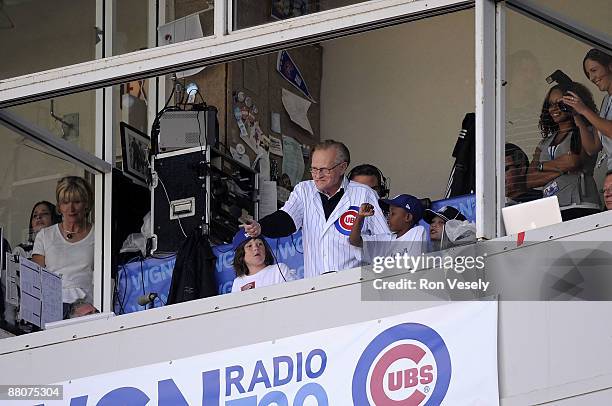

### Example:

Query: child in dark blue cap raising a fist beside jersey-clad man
xmin=349 ymin=195 xmax=427 ymax=262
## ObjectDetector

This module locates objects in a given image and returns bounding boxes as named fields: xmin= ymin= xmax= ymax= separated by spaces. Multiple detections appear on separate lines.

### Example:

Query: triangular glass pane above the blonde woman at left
xmin=9 ymin=90 xmax=96 ymax=154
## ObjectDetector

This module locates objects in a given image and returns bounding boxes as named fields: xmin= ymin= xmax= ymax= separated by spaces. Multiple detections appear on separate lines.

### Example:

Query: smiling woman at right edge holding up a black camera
xmin=563 ymin=49 xmax=612 ymax=170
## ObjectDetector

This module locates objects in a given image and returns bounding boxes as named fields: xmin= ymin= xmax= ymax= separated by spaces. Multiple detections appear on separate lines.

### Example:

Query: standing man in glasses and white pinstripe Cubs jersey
xmin=244 ymin=140 xmax=389 ymax=278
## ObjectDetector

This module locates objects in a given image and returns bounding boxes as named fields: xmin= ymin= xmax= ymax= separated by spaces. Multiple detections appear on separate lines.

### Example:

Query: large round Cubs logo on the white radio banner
xmin=352 ymin=323 xmax=451 ymax=406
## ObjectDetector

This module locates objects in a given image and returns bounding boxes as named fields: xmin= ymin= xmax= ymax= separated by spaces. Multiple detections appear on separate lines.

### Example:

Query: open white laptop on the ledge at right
xmin=502 ymin=196 xmax=562 ymax=235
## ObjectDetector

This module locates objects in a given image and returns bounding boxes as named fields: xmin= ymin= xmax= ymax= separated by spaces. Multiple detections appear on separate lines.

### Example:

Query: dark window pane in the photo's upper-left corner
xmin=0 ymin=0 xmax=95 ymax=79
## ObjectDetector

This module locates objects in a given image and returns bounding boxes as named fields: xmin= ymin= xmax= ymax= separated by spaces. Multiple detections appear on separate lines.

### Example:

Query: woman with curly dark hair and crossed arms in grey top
xmin=527 ymin=83 xmax=600 ymax=221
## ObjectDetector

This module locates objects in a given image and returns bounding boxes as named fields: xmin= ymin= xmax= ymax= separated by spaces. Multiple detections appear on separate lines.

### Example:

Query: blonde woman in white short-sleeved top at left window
xmin=32 ymin=176 xmax=94 ymax=317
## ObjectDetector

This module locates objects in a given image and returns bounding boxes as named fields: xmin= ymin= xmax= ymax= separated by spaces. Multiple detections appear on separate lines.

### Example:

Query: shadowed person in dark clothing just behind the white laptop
xmin=505 ymin=142 xmax=542 ymax=206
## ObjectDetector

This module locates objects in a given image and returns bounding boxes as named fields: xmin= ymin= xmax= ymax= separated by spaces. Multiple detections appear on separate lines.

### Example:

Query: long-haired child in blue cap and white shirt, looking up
xmin=232 ymin=231 xmax=297 ymax=292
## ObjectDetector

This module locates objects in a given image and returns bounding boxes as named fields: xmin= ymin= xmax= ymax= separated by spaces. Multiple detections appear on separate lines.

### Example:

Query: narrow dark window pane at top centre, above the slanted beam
xmin=233 ymin=0 xmax=368 ymax=29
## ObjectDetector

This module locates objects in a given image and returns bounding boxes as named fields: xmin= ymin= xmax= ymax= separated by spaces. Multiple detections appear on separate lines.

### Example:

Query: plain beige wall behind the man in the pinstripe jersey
xmin=321 ymin=10 xmax=474 ymax=199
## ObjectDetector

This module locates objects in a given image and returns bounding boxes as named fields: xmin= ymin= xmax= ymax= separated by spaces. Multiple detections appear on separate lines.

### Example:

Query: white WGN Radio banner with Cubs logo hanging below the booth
xmin=37 ymin=301 xmax=499 ymax=406
